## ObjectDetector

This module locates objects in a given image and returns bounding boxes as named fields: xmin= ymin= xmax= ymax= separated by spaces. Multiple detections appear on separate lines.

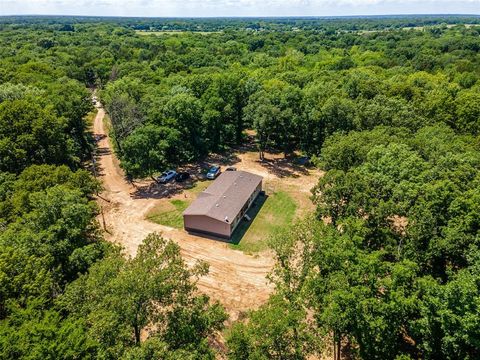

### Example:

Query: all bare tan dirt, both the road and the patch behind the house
xmin=93 ymin=108 xmax=318 ymax=320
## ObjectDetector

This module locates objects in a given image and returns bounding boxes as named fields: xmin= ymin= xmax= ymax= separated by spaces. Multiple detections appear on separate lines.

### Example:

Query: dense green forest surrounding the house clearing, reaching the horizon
xmin=0 ymin=16 xmax=480 ymax=360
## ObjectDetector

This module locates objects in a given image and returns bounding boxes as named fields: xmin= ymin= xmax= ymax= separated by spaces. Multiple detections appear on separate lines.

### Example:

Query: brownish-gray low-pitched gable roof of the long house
xmin=183 ymin=171 xmax=263 ymax=223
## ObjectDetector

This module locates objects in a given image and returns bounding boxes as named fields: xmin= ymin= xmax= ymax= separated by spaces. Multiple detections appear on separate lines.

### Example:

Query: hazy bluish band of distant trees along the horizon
xmin=0 ymin=15 xmax=480 ymax=32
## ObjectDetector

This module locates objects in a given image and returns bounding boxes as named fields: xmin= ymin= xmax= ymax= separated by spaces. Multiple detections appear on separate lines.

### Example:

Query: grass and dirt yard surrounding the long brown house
xmin=146 ymin=146 xmax=320 ymax=253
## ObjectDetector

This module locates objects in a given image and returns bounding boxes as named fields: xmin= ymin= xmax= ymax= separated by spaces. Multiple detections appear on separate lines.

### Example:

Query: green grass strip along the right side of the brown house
xmin=230 ymin=191 xmax=297 ymax=253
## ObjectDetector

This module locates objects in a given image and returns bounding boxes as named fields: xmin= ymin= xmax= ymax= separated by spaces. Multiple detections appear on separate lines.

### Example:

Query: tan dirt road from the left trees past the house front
xmin=94 ymin=108 xmax=273 ymax=320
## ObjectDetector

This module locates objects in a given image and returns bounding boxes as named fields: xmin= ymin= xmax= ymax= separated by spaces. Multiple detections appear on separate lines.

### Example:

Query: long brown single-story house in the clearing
xmin=183 ymin=171 xmax=263 ymax=239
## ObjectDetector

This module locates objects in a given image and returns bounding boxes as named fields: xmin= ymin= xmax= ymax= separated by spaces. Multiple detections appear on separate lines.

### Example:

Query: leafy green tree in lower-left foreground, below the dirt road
xmin=60 ymin=234 xmax=226 ymax=358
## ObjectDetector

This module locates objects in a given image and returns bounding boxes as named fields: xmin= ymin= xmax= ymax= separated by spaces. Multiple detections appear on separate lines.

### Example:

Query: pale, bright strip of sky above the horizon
xmin=0 ymin=0 xmax=480 ymax=17
